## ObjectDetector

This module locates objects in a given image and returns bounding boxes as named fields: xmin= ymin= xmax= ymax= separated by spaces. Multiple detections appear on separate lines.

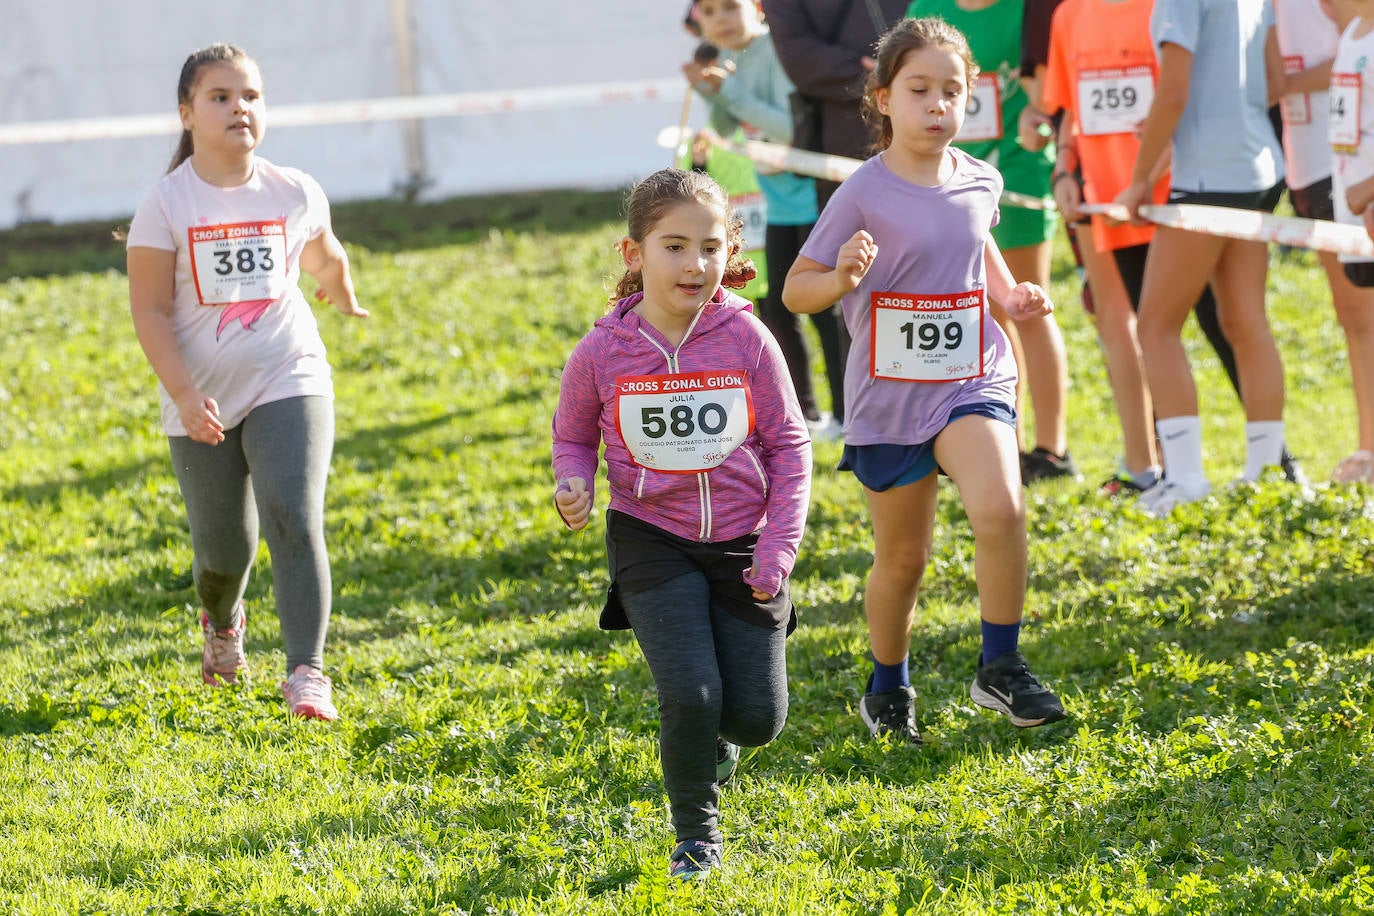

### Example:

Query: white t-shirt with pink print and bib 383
xmin=128 ymin=157 xmax=334 ymax=435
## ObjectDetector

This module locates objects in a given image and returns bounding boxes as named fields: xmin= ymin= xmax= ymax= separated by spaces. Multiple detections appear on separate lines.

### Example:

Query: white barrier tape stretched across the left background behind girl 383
xmin=0 ymin=78 xmax=683 ymax=146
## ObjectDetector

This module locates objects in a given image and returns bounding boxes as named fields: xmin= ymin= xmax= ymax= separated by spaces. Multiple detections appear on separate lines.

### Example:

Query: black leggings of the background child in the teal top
xmin=758 ymin=224 xmax=849 ymax=422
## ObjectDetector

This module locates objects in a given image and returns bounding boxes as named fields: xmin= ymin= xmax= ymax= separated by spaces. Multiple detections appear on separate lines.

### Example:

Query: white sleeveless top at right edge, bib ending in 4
xmin=1327 ymin=19 xmax=1374 ymax=261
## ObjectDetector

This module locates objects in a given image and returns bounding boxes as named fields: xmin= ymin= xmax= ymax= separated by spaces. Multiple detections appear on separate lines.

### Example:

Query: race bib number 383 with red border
xmin=187 ymin=220 xmax=286 ymax=305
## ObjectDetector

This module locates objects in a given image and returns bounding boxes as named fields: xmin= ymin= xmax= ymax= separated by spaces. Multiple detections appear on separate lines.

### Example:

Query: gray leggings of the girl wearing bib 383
xmin=168 ymin=397 xmax=334 ymax=673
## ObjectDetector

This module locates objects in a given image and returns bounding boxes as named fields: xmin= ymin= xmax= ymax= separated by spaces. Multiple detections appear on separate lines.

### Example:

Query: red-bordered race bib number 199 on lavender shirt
xmin=870 ymin=290 xmax=984 ymax=382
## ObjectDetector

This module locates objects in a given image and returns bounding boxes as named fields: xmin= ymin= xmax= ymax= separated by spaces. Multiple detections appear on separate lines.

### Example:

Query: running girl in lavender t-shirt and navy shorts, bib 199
xmin=783 ymin=19 xmax=1065 ymax=743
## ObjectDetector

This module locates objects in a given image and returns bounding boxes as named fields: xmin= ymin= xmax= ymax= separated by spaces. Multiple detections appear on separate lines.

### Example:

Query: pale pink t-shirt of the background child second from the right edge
xmin=1274 ymin=0 xmax=1340 ymax=188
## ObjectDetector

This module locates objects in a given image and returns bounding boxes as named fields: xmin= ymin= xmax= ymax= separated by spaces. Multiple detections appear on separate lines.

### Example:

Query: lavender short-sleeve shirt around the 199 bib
xmin=801 ymin=147 xmax=1017 ymax=445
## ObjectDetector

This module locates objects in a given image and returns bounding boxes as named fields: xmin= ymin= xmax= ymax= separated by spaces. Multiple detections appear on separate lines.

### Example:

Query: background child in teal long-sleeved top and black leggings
xmin=683 ymin=0 xmax=849 ymax=439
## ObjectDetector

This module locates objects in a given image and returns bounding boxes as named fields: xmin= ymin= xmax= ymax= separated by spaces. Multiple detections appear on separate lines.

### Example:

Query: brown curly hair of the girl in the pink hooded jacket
xmin=610 ymin=169 xmax=758 ymax=304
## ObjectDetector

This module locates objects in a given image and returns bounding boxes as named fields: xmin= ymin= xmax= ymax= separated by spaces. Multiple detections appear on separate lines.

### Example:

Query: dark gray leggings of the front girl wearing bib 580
xmin=620 ymin=573 xmax=787 ymax=843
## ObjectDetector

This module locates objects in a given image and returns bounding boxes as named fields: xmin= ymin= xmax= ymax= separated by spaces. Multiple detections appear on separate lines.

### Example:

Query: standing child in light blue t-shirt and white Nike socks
xmin=1116 ymin=0 xmax=1283 ymax=516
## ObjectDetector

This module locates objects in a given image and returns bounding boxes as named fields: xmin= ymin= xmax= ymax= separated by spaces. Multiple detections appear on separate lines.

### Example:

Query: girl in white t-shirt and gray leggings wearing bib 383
xmin=128 ymin=44 xmax=367 ymax=720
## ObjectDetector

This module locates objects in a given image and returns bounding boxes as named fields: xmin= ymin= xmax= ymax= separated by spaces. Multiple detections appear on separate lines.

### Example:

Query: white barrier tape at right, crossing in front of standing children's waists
xmin=1080 ymin=203 xmax=1374 ymax=258
